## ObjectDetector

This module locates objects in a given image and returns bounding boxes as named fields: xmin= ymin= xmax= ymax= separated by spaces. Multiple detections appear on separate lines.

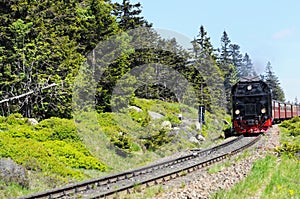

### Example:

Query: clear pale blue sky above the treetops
xmin=116 ymin=0 xmax=300 ymax=101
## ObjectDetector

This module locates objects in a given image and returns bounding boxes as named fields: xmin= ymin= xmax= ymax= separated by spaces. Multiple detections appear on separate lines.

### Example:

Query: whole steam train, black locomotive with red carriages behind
xmin=225 ymin=77 xmax=300 ymax=137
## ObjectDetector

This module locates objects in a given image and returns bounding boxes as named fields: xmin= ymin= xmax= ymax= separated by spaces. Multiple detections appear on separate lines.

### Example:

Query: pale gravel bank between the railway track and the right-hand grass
xmin=155 ymin=126 xmax=280 ymax=199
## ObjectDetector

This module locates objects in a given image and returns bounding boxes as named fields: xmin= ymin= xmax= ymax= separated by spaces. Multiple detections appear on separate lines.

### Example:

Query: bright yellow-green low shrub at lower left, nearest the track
xmin=0 ymin=136 xmax=106 ymax=178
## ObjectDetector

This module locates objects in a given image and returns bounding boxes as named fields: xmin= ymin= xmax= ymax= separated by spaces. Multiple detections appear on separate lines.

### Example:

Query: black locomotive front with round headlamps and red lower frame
xmin=231 ymin=80 xmax=272 ymax=134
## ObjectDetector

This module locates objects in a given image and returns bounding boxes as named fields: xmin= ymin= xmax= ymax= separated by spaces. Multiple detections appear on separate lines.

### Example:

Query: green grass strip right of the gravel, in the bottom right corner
xmin=212 ymin=117 xmax=300 ymax=199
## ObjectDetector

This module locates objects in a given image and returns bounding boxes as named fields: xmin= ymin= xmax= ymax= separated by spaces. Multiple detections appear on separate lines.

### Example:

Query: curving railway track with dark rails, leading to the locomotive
xmin=18 ymin=136 xmax=260 ymax=199
